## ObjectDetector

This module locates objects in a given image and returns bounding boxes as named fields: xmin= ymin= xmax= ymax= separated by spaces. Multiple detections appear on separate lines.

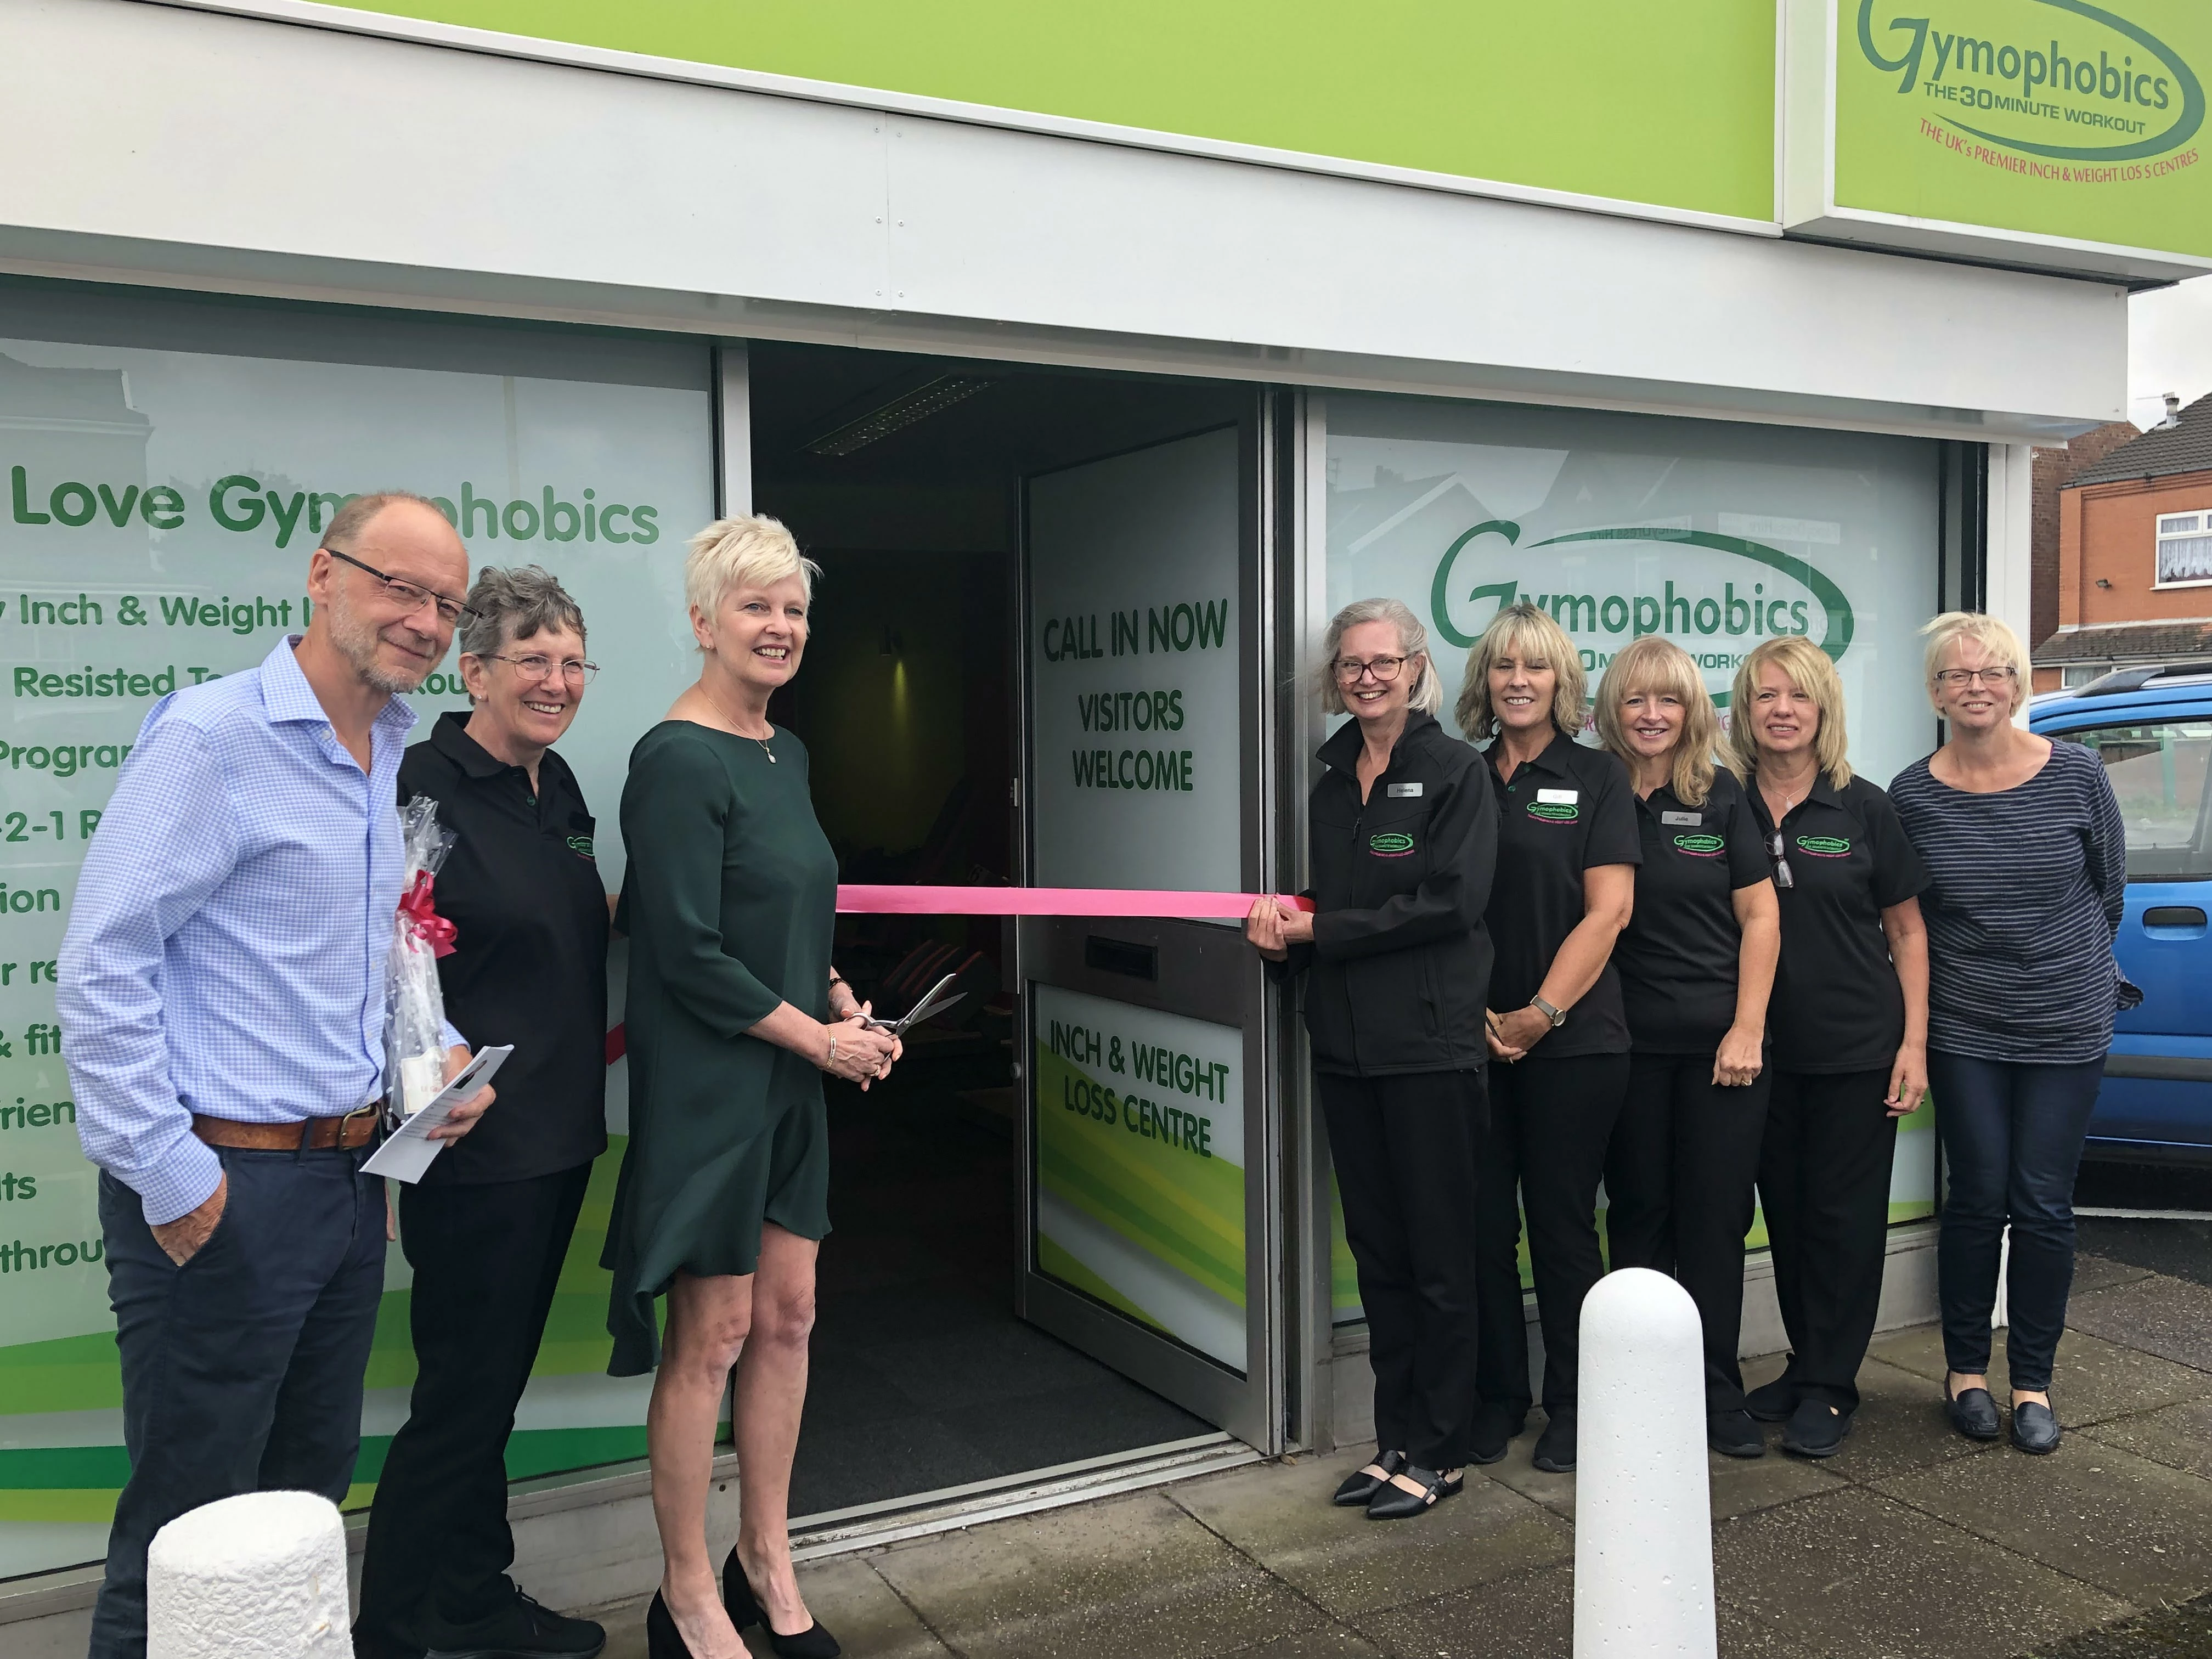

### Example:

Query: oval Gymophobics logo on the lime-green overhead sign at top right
xmin=1858 ymin=0 xmax=2205 ymax=163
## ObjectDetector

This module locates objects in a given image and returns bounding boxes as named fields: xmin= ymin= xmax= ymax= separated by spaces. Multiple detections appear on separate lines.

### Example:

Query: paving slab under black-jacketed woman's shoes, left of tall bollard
xmin=1168 ymin=1451 xmax=1575 ymax=1615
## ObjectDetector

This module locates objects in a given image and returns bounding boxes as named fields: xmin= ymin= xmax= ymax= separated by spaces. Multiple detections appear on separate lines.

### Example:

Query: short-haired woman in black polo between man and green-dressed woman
xmin=358 ymin=566 xmax=608 ymax=1655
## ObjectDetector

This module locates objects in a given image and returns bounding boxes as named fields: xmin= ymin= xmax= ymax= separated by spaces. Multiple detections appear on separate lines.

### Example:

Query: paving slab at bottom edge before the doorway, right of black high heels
xmin=865 ymin=1491 xmax=1327 ymax=1659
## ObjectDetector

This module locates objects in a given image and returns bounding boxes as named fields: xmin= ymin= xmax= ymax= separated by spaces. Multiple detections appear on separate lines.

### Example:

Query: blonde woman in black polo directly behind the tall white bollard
xmin=1597 ymin=635 xmax=1781 ymax=1458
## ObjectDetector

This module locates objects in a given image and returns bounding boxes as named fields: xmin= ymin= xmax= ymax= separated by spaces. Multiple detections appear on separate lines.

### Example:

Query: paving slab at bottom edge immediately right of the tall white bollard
xmin=1712 ymin=1469 xmax=2130 ymax=1659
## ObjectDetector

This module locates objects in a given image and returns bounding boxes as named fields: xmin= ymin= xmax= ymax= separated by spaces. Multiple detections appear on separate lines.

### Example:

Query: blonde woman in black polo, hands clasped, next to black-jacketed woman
xmin=1458 ymin=604 xmax=1644 ymax=1473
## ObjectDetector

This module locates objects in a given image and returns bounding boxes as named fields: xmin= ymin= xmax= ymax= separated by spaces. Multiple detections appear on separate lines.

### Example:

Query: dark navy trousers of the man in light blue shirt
xmin=91 ymin=1148 xmax=385 ymax=1659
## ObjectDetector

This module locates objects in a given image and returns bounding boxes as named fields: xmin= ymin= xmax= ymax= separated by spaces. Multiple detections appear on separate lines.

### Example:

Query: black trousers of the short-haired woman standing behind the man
xmin=358 ymin=1164 xmax=591 ymax=1648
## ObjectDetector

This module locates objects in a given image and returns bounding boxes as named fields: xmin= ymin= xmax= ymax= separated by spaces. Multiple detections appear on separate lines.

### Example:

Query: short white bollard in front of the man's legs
xmin=146 ymin=1491 xmax=354 ymax=1659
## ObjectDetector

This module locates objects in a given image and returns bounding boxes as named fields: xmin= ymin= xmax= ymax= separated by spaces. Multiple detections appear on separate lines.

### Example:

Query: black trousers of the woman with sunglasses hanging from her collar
xmin=1758 ymin=1066 xmax=1898 ymax=1411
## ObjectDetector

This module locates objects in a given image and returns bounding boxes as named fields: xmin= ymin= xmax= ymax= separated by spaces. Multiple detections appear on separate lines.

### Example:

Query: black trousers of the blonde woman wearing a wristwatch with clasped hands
xmin=1475 ymin=1048 xmax=1628 ymax=1415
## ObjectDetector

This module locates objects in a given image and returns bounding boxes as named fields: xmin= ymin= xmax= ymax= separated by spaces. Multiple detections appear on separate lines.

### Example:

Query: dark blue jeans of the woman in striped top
xmin=1929 ymin=1053 xmax=2103 ymax=1391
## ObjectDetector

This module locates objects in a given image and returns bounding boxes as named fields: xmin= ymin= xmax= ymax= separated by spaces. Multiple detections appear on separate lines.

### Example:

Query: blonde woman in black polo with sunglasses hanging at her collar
xmin=1728 ymin=635 xmax=1929 ymax=1458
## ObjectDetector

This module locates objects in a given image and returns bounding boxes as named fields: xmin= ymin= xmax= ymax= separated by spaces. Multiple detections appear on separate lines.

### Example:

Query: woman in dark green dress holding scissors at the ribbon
xmin=604 ymin=517 xmax=898 ymax=1659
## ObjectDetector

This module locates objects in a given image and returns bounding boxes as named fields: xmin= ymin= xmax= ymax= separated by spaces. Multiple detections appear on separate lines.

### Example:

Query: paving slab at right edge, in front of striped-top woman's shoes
xmin=1876 ymin=1438 xmax=2212 ymax=1606
